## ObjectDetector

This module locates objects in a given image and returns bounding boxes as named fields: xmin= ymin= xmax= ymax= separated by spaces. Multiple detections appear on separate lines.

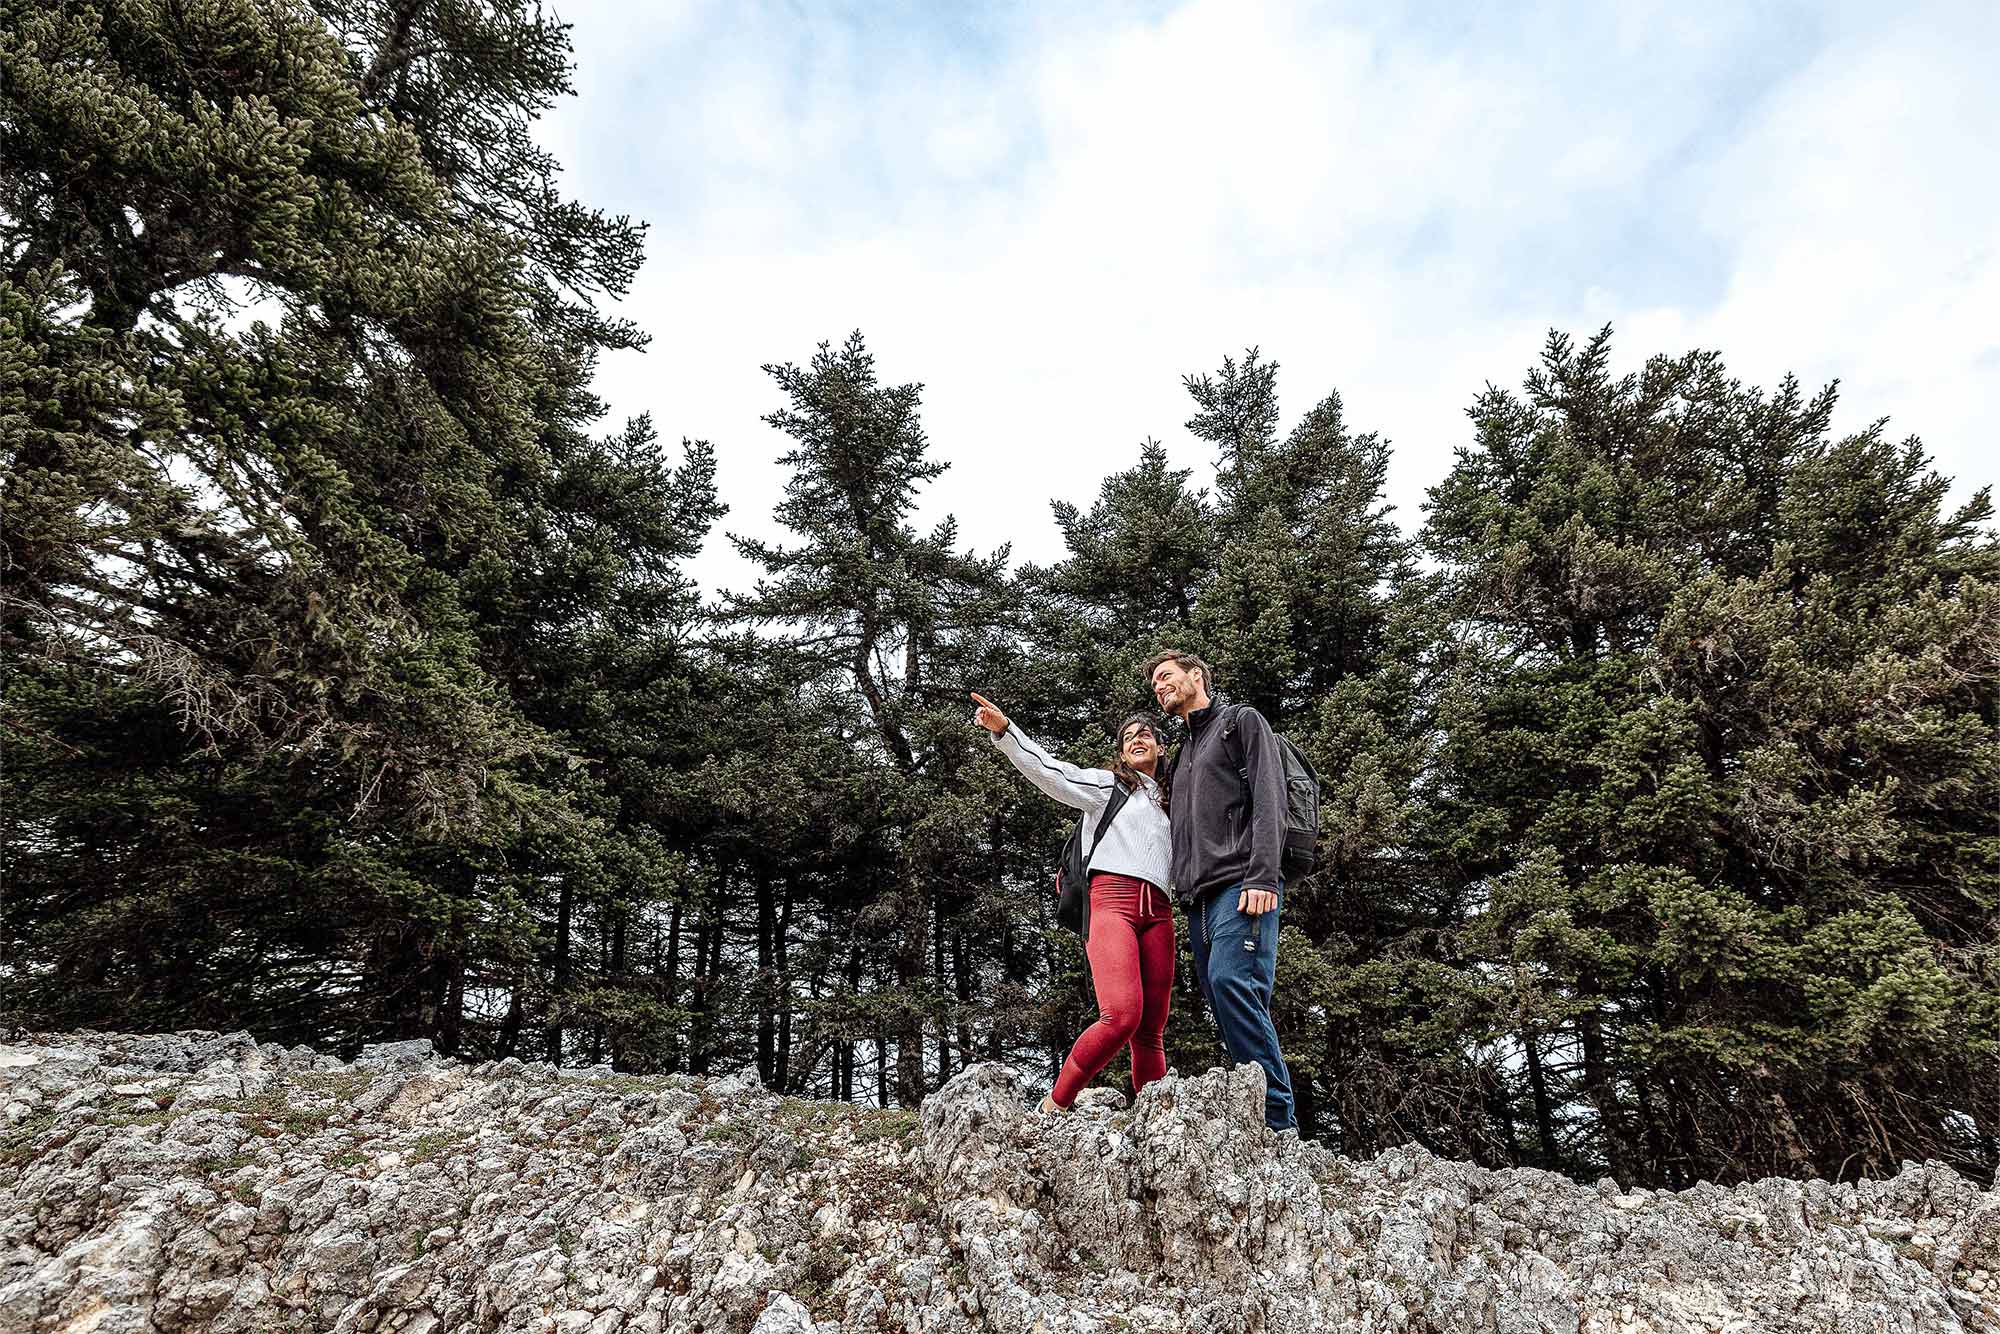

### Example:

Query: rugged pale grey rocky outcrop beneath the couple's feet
xmin=0 ymin=1034 xmax=2000 ymax=1334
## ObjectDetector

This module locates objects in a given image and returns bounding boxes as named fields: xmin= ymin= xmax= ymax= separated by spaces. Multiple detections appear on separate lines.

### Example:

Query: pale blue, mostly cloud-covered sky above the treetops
xmin=542 ymin=0 xmax=2000 ymax=588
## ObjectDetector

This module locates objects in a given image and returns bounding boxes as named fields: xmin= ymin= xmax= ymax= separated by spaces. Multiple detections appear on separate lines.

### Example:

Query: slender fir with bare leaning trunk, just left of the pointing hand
xmin=730 ymin=334 xmax=1008 ymax=1106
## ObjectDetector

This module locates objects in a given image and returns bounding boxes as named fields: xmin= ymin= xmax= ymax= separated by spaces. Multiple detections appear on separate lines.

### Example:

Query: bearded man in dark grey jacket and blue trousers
xmin=1146 ymin=650 xmax=1294 ymax=1130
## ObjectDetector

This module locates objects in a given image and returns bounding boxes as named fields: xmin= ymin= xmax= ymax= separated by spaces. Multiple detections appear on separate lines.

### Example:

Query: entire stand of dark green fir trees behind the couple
xmin=0 ymin=0 xmax=2000 ymax=1184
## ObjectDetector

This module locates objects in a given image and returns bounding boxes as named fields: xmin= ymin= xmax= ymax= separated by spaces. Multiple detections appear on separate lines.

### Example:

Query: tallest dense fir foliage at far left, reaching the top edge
xmin=0 ymin=0 xmax=718 ymax=1048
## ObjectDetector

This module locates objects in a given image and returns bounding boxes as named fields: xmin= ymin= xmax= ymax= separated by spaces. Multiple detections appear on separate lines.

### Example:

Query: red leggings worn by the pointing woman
xmin=1048 ymin=870 xmax=1174 ymax=1108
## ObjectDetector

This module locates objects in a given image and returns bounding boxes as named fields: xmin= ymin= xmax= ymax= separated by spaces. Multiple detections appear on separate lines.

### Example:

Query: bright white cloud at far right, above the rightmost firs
xmin=1624 ymin=22 xmax=2000 ymax=500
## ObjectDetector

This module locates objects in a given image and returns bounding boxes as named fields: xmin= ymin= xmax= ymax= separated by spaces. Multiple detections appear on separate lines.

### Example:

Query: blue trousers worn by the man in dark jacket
xmin=1188 ymin=884 xmax=1294 ymax=1130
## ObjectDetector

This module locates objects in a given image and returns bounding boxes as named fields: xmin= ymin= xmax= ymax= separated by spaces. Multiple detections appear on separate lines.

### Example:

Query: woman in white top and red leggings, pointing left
xmin=972 ymin=694 xmax=1174 ymax=1112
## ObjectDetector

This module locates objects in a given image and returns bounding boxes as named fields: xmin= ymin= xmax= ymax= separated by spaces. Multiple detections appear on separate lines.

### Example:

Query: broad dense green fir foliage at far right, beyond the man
xmin=1428 ymin=334 xmax=2000 ymax=1182
